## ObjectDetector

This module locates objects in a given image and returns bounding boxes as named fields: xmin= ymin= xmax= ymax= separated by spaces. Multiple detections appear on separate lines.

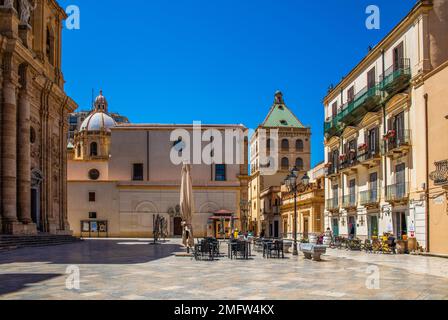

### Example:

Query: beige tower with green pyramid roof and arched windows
xmin=248 ymin=91 xmax=311 ymax=236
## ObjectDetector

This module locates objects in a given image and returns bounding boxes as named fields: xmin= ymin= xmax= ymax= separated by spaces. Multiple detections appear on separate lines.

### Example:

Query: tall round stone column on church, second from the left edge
xmin=17 ymin=79 xmax=33 ymax=225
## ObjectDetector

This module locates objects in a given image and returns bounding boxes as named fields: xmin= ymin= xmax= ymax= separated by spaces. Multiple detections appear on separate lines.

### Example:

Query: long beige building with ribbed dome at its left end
xmin=68 ymin=94 xmax=248 ymax=238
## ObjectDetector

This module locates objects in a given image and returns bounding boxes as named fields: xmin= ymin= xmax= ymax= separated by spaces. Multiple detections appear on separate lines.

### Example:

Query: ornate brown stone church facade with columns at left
xmin=0 ymin=0 xmax=77 ymax=235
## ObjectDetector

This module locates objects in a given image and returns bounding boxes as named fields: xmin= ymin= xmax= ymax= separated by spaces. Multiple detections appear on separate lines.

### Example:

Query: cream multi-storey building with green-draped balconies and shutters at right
xmin=324 ymin=0 xmax=448 ymax=250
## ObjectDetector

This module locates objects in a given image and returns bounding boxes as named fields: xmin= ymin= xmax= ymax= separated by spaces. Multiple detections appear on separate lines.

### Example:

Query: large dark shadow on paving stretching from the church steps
xmin=0 ymin=240 xmax=183 ymax=265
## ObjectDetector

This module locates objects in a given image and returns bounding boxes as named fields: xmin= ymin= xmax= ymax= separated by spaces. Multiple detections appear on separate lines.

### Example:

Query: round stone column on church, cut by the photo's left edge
xmin=1 ymin=79 xmax=17 ymax=228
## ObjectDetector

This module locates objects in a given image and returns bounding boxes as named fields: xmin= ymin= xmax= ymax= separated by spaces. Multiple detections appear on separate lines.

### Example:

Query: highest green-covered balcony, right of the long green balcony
xmin=380 ymin=59 xmax=411 ymax=96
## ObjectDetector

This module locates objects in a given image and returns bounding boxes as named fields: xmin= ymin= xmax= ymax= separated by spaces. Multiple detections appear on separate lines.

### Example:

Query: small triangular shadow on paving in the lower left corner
xmin=0 ymin=274 xmax=61 ymax=296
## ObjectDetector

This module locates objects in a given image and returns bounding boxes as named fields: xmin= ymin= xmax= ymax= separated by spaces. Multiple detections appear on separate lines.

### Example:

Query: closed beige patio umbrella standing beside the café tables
xmin=180 ymin=164 xmax=194 ymax=250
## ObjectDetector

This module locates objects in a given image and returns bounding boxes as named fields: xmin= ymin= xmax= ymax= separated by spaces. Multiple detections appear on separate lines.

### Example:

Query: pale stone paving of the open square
xmin=0 ymin=239 xmax=448 ymax=300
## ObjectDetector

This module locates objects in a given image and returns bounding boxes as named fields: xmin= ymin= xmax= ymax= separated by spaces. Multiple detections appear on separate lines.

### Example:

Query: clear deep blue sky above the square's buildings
xmin=59 ymin=0 xmax=415 ymax=164
